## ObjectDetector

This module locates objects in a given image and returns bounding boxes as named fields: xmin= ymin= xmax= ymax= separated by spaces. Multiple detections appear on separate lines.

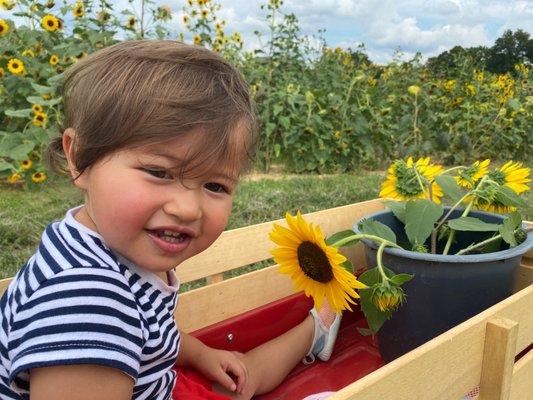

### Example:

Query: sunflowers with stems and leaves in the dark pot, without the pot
xmin=270 ymin=157 xmax=531 ymax=333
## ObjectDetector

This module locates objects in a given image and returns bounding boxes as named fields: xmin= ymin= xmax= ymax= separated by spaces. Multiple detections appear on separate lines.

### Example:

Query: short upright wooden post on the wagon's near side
xmin=479 ymin=318 xmax=518 ymax=400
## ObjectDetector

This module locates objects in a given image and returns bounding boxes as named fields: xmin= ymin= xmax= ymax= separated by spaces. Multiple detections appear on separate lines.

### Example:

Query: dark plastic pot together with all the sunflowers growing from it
xmin=271 ymin=157 xmax=533 ymax=361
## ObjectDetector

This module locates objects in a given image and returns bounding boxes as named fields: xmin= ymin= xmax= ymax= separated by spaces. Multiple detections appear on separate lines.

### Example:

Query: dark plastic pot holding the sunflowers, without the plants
xmin=354 ymin=210 xmax=533 ymax=361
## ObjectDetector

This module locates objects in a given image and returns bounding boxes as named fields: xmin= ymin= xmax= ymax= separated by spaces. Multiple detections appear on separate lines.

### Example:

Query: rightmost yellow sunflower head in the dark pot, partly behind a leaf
xmin=475 ymin=161 xmax=531 ymax=214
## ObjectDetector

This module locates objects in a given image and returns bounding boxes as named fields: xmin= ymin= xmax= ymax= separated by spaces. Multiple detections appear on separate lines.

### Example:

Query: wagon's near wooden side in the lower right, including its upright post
xmin=331 ymin=285 xmax=533 ymax=400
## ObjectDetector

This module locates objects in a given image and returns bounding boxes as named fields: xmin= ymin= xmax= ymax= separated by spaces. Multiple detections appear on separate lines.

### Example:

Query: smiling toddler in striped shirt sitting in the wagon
xmin=0 ymin=40 xmax=340 ymax=400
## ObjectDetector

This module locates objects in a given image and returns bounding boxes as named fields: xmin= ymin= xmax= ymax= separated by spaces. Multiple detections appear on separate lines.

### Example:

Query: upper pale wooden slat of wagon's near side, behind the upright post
xmin=331 ymin=285 xmax=533 ymax=400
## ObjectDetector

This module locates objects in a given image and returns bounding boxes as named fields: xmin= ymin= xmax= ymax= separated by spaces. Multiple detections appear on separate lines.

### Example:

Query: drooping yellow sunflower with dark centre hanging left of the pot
xmin=270 ymin=211 xmax=366 ymax=313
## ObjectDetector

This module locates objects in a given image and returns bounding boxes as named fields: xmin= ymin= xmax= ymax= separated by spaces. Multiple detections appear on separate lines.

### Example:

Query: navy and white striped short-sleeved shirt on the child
xmin=0 ymin=207 xmax=180 ymax=400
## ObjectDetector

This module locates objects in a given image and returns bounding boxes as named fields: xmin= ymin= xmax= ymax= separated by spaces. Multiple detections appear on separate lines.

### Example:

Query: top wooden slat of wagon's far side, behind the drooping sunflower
xmin=176 ymin=199 xmax=384 ymax=282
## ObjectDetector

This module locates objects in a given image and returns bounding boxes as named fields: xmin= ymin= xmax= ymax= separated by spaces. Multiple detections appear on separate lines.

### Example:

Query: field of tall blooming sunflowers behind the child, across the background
xmin=0 ymin=0 xmax=533 ymax=187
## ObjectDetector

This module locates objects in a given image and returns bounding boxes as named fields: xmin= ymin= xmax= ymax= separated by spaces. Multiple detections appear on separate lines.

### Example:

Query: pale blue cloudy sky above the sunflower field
xmin=0 ymin=0 xmax=533 ymax=63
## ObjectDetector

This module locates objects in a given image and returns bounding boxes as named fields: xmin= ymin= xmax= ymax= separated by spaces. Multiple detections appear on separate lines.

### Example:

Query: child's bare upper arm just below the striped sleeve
xmin=30 ymin=365 xmax=133 ymax=400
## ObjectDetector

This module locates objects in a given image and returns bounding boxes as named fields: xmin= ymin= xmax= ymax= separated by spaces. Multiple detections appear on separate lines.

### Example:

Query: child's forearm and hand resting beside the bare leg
xmin=177 ymin=332 xmax=248 ymax=394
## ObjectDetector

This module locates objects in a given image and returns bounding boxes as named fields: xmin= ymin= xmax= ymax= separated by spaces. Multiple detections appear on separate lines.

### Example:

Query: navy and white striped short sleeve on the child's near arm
xmin=8 ymin=267 xmax=144 ymax=392
